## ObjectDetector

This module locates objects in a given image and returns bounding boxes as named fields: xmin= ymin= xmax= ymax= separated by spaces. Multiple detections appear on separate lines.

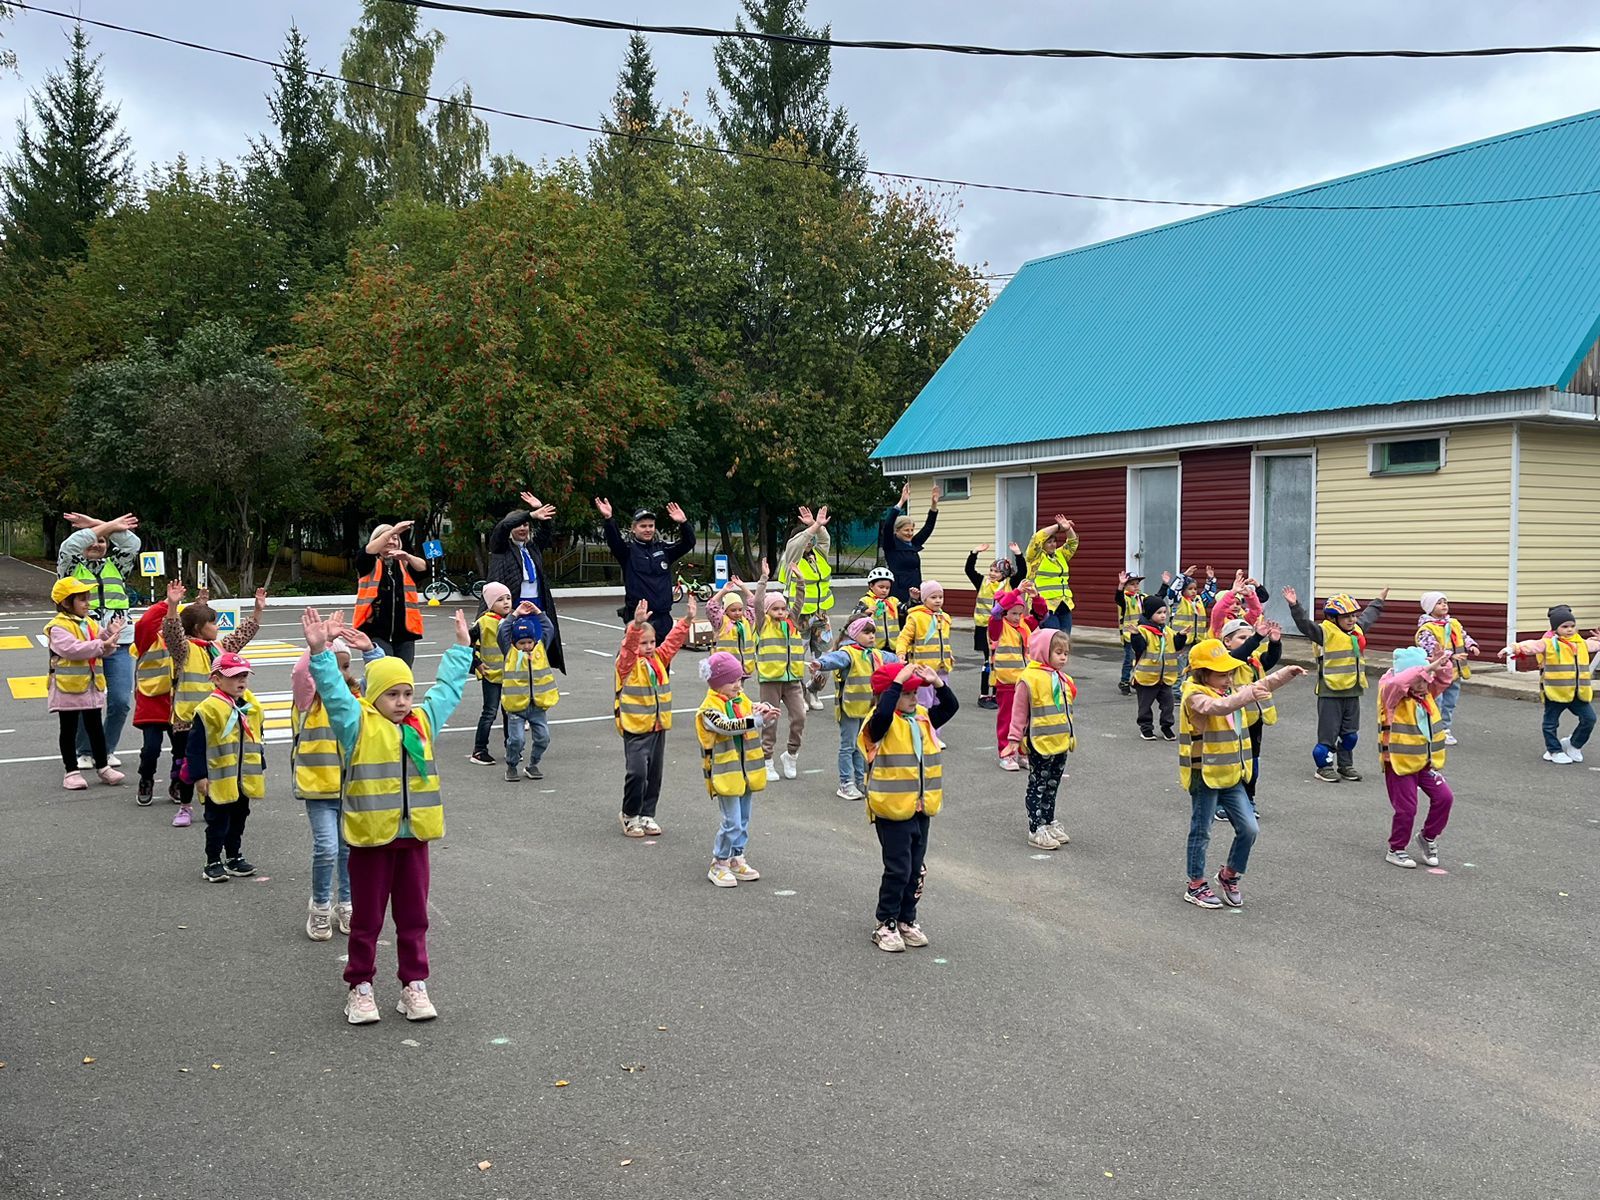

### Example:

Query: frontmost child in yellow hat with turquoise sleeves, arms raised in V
xmin=301 ymin=608 xmax=472 ymax=1026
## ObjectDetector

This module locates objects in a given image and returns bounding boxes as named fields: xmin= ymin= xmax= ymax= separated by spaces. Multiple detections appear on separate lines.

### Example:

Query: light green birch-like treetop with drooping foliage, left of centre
xmin=339 ymin=0 xmax=490 ymax=208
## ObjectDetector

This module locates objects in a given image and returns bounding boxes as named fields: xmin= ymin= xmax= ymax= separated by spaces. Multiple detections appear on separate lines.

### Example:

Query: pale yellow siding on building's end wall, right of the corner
xmin=1510 ymin=422 xmax=1600 ymax=634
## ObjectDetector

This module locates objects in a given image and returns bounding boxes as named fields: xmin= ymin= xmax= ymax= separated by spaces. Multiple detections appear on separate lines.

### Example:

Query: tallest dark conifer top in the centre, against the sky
xmin=707 ymin=0 xmax=867 ymax=179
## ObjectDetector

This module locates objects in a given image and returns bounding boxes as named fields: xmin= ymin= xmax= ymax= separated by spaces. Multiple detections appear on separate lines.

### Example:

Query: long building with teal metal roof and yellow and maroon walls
xmin=874 ymin=112 xmax=1600 ymax=659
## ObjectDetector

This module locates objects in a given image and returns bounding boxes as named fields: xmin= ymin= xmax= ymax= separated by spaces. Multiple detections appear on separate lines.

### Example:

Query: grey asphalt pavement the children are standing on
xmin=0 ymin=602 xmax=1600 ymax=1200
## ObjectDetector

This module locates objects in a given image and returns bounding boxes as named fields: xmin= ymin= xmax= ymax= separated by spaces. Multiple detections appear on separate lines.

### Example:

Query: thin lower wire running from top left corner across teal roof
xmin=5 ymin=0 xmax=1600 ymax=213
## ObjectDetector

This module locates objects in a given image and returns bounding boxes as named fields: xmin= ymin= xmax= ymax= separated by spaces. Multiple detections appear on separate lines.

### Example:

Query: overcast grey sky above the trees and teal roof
xmin=0 ymin=0 xmax=1600 ymax=272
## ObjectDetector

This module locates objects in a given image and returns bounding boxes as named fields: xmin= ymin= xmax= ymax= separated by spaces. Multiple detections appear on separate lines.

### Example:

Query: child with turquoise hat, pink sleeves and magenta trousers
xmin=1378 ymin=646 xmax=1456 ymax=869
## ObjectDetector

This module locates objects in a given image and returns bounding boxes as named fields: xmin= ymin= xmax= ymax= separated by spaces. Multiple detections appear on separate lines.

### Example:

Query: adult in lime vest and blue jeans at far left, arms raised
xmin=56 ymin=512 xmax=139 ymax=771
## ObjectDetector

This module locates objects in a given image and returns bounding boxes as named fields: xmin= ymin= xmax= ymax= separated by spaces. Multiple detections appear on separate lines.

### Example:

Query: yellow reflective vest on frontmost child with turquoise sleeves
xmin=341 ymin=710 xmax=445 ymax=846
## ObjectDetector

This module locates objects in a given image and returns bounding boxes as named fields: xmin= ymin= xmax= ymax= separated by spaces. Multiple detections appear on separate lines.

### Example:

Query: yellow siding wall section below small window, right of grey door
xmin=1315 ymin=424 xmax=1510 ymax=605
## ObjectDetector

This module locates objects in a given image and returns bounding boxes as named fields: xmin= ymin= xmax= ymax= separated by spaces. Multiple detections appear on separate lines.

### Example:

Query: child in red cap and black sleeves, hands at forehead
xmin=861 ymin=662 xmax=960 ymax=950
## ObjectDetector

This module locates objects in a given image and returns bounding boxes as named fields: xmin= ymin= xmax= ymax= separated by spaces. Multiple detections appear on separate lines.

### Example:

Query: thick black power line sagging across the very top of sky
xmin=389 ymin=0 xmax=1600 ymax=62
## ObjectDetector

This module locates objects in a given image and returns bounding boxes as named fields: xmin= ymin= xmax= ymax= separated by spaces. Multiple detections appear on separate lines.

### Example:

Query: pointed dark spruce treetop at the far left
xmin=0 ymin=26 xmax=130 ymax=266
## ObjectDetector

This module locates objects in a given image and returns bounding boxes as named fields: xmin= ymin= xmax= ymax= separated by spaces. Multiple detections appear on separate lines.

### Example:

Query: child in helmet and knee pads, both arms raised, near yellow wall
xmin=1283 ymin=587 xmax=1389 ymax=784
